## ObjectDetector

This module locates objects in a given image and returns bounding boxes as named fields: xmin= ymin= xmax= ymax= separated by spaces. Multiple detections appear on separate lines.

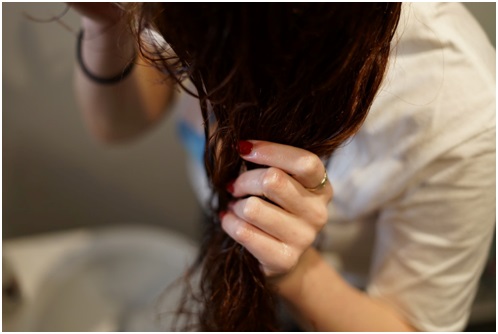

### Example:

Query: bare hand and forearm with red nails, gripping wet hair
xmin=222 ymin=140 xmax=414 ymax=331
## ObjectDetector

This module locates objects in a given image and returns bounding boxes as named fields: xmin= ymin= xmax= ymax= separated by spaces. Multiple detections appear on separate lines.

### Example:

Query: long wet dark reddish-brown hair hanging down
xmin=129 ymin=3 xmax=401 ymax=331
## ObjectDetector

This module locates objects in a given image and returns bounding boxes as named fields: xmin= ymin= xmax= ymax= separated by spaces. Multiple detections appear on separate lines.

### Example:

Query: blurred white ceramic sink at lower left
xmin=3 ymin=225 xmax=196 ymax=331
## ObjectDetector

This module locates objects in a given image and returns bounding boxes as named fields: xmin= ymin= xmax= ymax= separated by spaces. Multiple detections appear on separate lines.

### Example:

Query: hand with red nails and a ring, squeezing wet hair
xmin=222 ymin=140 xmax=333 ymax=276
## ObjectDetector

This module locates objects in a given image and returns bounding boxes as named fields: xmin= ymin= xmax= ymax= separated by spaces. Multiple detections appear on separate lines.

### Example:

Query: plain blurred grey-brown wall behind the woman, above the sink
xmin=2 ymin=3 xmax=496 ymax=238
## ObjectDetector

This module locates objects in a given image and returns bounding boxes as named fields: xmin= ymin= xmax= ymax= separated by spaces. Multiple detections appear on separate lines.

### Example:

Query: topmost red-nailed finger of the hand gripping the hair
xmin=239 ymin=140 xmax=331 ymax=192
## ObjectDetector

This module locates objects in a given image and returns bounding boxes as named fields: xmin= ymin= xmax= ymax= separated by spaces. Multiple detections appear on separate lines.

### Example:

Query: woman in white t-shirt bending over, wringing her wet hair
xmin=73 ymin=4 xmax=495 ymax=331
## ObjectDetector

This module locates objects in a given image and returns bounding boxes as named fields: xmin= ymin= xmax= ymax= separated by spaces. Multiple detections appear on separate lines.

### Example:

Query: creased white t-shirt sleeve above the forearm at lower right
xmin=367 ymin=127 xmax=496 ymax=331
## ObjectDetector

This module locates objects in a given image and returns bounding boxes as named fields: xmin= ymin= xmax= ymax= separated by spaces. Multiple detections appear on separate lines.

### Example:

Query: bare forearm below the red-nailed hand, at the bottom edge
xmin=276 ymin=248 xmax=415 ymax=332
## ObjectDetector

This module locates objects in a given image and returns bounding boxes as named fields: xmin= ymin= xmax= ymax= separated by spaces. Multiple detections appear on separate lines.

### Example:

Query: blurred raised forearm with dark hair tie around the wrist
xmin=75 ymin=18 xmax=173 ymax=142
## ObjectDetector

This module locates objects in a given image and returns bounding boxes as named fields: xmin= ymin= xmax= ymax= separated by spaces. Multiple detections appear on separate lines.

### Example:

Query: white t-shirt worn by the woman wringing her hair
xmin=174 ymin=3 xmax=496 ymax=331
